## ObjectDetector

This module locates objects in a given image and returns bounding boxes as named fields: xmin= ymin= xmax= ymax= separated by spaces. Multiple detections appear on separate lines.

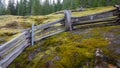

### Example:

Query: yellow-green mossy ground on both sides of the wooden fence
xmin=0 ymin=6 xmax=120 ymax=68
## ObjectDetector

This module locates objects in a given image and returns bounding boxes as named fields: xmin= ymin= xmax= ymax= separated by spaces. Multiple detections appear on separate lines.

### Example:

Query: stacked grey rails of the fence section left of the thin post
xmin=0 ymin=32 xmax=29 ymax=68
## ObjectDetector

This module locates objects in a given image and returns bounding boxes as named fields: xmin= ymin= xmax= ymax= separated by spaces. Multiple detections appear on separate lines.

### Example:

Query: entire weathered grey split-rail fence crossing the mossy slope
xmin=0 ymin=5 xmax=120 ymax=68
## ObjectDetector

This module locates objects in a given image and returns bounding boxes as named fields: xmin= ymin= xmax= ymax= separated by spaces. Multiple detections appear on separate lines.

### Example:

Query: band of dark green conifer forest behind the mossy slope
xmin=0 ymin=0 xmax=120 ymax=16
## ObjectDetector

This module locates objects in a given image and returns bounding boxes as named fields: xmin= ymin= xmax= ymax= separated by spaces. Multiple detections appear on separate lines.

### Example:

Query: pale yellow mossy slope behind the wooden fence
xmin=0 ymin=6 xmax=114 ymax=45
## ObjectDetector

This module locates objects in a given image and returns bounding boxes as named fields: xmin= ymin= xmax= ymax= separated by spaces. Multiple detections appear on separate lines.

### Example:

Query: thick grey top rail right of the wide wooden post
xmin=72 ymin=9 xmax=117 ymax=23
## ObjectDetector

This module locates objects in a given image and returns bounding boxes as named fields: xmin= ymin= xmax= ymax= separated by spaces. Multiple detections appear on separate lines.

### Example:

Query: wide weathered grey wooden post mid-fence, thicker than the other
xmin=64 ymin=10 xmax=73 ymax=31
